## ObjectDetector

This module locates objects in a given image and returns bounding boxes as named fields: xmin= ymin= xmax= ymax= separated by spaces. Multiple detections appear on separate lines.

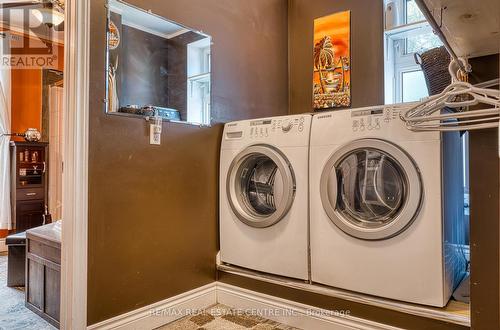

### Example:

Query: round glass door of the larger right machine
xmin=320 ymin=139 xmax=422 ymax=240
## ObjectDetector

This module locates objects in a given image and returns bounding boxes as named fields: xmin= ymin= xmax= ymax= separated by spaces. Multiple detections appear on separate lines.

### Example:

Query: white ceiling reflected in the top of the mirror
xmin=110 ymin=0 xmax=189 ymax=39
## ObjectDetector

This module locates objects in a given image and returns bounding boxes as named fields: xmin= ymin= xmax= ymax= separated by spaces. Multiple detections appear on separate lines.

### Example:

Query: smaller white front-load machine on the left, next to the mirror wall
xmin=219 ymin=115 xmax=311 ymax=280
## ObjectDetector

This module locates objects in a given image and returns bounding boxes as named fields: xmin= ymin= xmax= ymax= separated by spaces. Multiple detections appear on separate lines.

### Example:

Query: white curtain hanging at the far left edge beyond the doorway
xmin=0 ymin=37 xmax=12 ymax=230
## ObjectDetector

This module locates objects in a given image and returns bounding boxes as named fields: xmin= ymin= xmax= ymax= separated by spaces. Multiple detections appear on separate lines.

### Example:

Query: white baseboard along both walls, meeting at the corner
xmin=87 ymin=282 xmax=401 ymax=330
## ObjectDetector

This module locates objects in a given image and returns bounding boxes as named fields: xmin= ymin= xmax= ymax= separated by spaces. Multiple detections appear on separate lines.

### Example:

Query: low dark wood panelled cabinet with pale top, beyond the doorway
xmin=26 ymin=222 xmax=61 ymax=327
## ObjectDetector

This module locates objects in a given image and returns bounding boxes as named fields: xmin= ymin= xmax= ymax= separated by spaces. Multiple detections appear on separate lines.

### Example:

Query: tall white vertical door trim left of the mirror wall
xmin=60 ymin=0 xmax=90 ymax=330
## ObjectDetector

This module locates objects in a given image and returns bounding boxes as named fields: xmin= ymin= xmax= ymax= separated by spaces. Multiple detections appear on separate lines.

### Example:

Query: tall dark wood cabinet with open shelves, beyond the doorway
xmin=10 ymin=141 xmax=49 ymax=233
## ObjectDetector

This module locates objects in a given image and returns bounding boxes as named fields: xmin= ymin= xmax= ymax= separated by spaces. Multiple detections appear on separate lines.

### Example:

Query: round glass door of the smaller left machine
xmin=226 ymin=145 xmax=295 ymax=227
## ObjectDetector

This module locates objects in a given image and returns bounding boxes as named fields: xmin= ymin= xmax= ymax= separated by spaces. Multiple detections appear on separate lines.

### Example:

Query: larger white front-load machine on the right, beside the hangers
xmin=310 ymin=105 xmax=466 ymax=306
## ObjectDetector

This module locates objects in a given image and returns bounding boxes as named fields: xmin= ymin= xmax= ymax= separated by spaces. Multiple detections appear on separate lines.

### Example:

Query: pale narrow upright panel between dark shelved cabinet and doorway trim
xmin=49 ymin=86 xmax=64 ymax=221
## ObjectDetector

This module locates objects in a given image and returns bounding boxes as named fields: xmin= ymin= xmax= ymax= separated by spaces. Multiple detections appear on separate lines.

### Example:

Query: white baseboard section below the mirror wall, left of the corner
xmin=87 ymin=282 xmax=217 ymax=330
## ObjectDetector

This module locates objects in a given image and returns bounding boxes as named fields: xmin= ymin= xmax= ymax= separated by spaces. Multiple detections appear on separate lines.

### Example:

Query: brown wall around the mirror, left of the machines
xmin=88 ymin=0 xmax=288 ymax=324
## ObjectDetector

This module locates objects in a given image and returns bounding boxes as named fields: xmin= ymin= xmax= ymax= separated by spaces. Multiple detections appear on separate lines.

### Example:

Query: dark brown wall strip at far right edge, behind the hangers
xmin=469 ymin=55 xmax=500 ymax=330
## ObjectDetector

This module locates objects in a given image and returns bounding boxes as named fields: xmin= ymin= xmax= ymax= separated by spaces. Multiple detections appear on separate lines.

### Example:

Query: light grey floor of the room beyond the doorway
xmin=0 ymin=255 xmax=55 ymax=330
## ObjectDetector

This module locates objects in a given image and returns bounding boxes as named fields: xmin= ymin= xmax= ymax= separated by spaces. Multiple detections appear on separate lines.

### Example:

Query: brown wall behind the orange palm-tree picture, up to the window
xmin=288 ymin=0 xmax=384 ymax=114
